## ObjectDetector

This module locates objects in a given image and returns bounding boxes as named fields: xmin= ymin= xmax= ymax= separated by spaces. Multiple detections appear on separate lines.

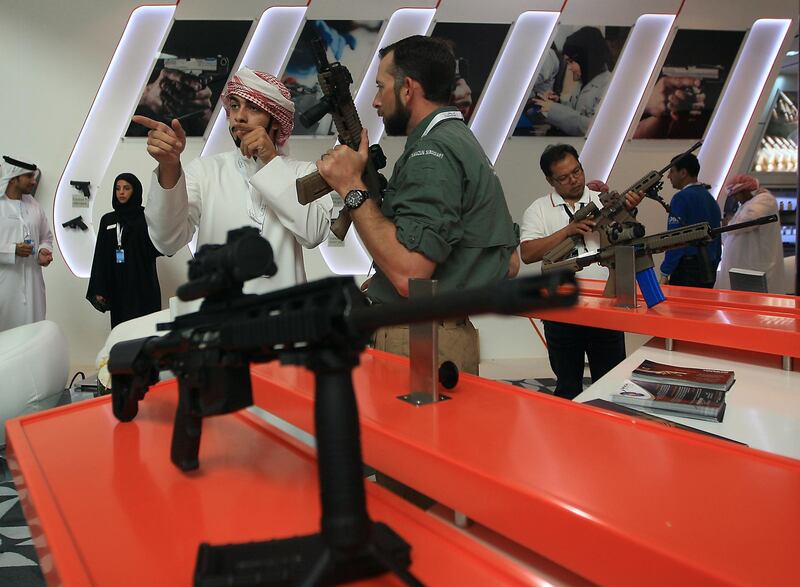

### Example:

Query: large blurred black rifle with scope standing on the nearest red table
xmin=108 ymin=228 xmax=578 ymax=587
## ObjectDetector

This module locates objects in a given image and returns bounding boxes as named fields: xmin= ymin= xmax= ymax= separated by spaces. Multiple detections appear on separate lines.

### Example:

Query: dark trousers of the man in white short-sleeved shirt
xmin=543 ymin=321 xmax=625 ymax=399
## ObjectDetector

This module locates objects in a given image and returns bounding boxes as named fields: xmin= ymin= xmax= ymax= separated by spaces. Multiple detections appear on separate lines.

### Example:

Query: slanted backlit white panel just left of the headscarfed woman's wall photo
xmin=470 ymin=11 xmax=560 ymax=163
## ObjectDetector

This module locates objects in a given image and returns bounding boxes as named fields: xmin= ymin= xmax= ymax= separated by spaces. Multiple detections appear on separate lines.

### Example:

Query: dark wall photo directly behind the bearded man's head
xmin=431 ymin=22 xmax=511 ymax=122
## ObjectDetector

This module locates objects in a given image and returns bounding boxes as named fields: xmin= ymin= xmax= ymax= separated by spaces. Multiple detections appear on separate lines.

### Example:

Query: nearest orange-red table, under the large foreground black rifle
xmin=7 ymin=382 xmax=544 ymax=587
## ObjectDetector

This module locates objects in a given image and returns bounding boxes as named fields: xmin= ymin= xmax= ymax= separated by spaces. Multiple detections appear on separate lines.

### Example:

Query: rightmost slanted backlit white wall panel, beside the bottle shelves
xmin=697 ymin=18 xmax=791 ymax=194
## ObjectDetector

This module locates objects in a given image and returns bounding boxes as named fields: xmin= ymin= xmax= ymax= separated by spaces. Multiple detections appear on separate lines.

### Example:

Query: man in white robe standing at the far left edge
xmin=0 ymin=157 xmax=53 ymax=331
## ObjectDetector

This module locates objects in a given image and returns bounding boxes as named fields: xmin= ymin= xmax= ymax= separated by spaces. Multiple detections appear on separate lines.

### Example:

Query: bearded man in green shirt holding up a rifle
xmin=317 ymin=36 xmax=519 ymax=373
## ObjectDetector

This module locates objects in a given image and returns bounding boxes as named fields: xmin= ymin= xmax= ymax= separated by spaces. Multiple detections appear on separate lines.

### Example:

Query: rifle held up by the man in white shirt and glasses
xmin=542 ymin=141 xmax=703 ymax=266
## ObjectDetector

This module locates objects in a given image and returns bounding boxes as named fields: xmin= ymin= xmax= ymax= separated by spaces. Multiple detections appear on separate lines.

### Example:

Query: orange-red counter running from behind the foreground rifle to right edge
xmin=253 ymin=351 xmax=800 ymax=585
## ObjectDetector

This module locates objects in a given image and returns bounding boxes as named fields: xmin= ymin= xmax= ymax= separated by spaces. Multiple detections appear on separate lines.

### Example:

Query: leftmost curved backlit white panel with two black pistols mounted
xmin=53 ymin=6 xmax=175 ymax=277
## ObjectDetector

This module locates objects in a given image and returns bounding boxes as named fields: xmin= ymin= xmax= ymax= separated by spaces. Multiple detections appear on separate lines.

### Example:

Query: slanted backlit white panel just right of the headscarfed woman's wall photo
xmin=581 ymin=14 xmax=675 ymax=181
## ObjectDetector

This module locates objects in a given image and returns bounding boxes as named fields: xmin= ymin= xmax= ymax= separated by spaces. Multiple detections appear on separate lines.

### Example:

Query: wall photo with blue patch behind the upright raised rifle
xmin=282 ymin=20 xmax=383 ymax=136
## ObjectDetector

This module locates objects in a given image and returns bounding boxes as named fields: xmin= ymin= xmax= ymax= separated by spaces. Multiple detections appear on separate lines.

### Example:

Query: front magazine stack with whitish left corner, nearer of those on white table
xmin=611 ymin=379 xmax=725 ymax=422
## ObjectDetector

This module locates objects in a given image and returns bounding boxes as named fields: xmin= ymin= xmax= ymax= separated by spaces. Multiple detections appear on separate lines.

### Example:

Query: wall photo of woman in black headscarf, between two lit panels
xmin=513 ymin=25 xmax=630 ymax=136
